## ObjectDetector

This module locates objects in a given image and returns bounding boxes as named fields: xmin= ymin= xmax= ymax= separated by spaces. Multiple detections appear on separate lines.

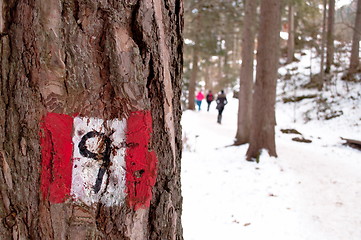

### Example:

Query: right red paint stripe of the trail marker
xmin=125 ymin=111 xmax=157 ymax=210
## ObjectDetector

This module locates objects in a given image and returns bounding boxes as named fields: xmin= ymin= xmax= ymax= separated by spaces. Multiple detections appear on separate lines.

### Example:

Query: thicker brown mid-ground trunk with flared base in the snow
xmin=247 ymin=0 xmax=281 ymax=160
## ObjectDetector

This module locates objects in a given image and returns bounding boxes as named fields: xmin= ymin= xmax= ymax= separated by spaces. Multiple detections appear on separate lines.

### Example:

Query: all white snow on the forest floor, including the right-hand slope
xmin=181 ymin=48 xmax=361 ymax=240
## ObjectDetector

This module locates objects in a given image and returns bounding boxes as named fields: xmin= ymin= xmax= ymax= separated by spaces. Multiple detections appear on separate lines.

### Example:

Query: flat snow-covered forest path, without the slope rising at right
xmin=182 ymin=99 xmax=361 ymax=240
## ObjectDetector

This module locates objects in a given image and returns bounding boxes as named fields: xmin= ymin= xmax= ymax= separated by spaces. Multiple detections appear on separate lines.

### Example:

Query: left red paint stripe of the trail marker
xmin=40 ymin=113 xmax=73 ymax=203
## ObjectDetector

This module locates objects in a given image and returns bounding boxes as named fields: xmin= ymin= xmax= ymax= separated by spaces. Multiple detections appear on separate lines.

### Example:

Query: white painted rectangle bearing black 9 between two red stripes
xmin=71 ymin=117 xmax=126 ymax=206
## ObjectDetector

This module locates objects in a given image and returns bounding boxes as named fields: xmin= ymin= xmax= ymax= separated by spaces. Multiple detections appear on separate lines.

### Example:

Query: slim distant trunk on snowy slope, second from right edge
xmin=325 ymin=0 xmax=335 ymax=73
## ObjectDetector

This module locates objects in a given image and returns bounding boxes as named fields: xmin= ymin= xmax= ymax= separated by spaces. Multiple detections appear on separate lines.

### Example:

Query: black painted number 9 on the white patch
xmin=78 ymin=131 xmax=111 ymax=193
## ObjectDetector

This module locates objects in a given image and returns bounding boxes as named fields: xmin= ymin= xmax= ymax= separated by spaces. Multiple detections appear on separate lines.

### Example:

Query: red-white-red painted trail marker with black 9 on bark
xmin=40 ymin=111 xmax=157 ymax=210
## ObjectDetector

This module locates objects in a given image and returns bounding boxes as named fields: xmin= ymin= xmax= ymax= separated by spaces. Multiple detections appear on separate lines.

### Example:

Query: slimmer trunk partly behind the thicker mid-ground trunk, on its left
xmin=235 ymin=0 xmax=258 ymax=145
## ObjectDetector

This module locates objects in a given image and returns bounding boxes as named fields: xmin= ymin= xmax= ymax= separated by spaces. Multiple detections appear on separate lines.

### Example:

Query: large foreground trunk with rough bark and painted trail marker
xmin=0 ymin=0 xmax=183 ymax=240
